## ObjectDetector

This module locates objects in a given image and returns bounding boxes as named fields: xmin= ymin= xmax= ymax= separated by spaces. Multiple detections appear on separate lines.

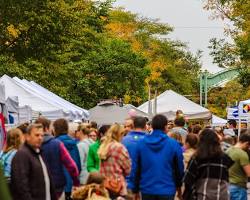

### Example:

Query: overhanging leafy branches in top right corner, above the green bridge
xmin=205 ymin=0 xmax=250 ymax=67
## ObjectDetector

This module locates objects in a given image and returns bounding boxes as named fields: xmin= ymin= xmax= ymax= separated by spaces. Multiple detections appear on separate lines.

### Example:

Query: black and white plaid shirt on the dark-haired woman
xmin=183 ymin=154 xmax=233 ymax=200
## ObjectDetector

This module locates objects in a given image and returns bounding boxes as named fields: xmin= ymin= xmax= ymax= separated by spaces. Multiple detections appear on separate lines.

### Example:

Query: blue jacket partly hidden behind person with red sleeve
xmin=57 ymin=134 xmax=81 ymax=192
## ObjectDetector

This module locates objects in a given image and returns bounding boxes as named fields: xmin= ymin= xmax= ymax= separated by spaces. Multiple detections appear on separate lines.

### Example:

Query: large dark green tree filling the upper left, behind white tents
xmin=0 ymin=0 xmax=147 ymax=108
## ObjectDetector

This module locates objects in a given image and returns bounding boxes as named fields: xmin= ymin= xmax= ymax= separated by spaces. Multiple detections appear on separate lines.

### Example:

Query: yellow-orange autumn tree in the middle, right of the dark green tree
xmin=106 ymin=9 xmax=200 ymax=97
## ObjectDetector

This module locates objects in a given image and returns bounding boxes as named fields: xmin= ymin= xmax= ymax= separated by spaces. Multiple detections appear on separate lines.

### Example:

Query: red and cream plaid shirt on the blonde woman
xmin=100 ymin=142 xmax=131 ymax=195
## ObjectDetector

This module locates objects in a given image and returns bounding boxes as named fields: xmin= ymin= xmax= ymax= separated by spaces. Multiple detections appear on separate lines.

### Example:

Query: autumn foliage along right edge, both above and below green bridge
xmin=205 ymin=0 xmax=250 ymax=113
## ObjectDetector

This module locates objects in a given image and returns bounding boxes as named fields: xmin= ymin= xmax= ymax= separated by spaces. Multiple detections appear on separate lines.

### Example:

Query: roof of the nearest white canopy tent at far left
xmin=0 ymin=75 xmax=88 ymax=120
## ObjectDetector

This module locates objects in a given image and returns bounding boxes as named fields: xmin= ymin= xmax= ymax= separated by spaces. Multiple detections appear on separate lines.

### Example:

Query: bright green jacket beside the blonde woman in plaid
xmin=87 ymin=140 xmax=101 ymax=172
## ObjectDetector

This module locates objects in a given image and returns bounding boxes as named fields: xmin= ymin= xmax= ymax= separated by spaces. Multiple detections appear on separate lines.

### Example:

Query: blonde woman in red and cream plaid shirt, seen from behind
xmin=98 ymin=124 xmax=131 ymax=198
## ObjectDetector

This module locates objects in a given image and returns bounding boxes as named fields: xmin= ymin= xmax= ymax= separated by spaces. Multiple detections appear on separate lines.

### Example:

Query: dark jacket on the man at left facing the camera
xmin=11 ymin=143 xmax=56 ymax=200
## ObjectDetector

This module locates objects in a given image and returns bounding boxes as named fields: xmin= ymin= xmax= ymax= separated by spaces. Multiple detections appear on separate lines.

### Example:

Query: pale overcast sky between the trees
xmin=114 ymin=0 xmax=229 ymax=73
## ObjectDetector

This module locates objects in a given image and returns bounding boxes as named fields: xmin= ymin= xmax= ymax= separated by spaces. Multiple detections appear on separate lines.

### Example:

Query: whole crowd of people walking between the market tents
xmin=0 ymin=112 xmax=250 ymax=200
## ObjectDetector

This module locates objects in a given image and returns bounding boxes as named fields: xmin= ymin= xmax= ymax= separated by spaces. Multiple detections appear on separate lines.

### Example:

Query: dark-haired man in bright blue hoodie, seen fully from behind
xmin=130 ymin=115 xmax=184 ymax=200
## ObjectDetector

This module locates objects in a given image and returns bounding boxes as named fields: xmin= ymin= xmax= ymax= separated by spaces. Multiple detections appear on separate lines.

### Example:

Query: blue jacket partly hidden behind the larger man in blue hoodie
xmin=122 ymin=131 xmax=145 ymax=189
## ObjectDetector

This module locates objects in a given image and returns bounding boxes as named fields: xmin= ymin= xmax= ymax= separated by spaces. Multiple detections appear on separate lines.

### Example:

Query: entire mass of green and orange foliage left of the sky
xmin=0 ymin=0 xmax=200 ymax=108
